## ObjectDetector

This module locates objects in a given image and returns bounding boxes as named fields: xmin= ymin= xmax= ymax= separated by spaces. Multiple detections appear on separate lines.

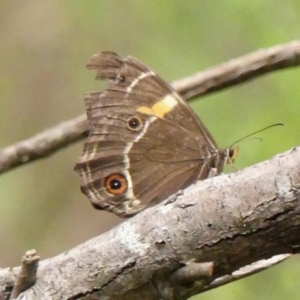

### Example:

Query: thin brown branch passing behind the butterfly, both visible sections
xmin=0 ymin=41 xmax=300 ymax=174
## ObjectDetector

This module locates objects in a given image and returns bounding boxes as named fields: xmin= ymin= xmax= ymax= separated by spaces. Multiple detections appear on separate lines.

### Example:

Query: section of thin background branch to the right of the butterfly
xmin=172 ymin=41 xmax=300 ymax=100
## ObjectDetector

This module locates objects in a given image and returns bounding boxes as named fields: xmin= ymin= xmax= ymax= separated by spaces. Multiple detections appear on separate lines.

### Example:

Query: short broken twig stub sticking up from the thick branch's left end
xmin=9 ymin=250 xmax=40 ymax=300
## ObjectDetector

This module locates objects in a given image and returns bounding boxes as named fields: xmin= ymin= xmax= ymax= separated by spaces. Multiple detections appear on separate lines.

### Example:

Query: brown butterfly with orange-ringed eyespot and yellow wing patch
xmin=75 ymin=52 xmax=236 ymax=217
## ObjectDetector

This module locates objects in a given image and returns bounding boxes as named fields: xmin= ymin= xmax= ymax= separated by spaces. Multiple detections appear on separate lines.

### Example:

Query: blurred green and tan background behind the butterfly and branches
xmin=0 ymin=0 xmax=300 ymax=300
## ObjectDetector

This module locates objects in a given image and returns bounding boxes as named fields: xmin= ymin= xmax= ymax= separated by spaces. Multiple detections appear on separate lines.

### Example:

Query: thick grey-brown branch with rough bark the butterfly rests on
xmin=0 ymin=147 xmax=300 ymax=300
